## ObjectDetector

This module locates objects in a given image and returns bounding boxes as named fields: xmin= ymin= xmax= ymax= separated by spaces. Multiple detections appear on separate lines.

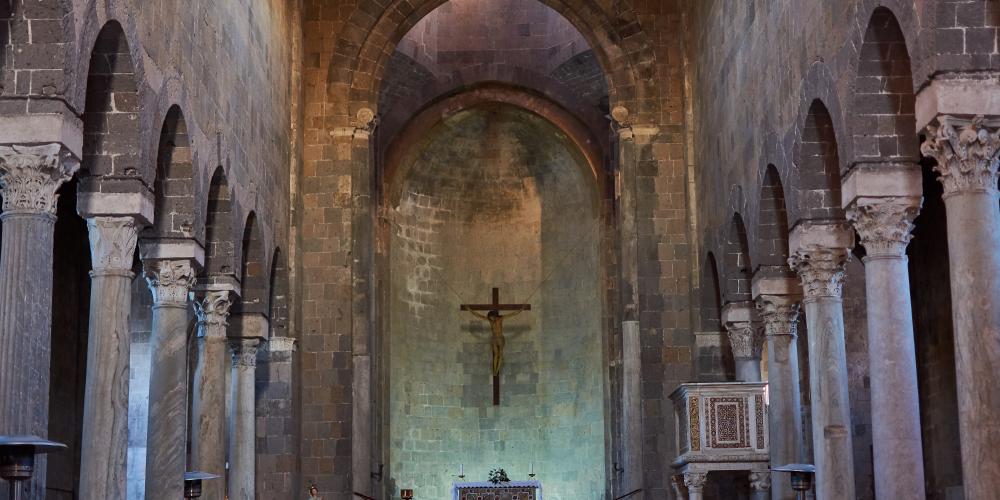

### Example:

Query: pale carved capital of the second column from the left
xmin=87 ymin=217 xmax=139 ymax=274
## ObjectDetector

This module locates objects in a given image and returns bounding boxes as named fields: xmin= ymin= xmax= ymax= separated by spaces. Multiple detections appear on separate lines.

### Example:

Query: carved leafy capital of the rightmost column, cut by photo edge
xmin=920 ymin=115 xmax=1000 ymax=198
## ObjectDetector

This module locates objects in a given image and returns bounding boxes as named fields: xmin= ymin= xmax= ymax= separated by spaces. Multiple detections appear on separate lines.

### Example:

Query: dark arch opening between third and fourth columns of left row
xmin=204 ymin=166 xmax=236 ymax=278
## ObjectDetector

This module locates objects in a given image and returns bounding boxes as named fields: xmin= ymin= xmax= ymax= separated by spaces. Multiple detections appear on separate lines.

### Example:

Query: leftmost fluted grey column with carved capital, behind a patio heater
xmin=0 ymin=143 xmax=79 ymax=499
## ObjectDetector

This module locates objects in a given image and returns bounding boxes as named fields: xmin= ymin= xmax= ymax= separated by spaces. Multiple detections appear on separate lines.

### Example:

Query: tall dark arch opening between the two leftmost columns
xmin=81 ymin=21 xmax=142 ymax=177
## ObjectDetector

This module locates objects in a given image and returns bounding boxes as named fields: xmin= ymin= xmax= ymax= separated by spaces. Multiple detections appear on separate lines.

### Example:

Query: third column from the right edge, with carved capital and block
xmin=788 ymin=221 xmax=855 ymax=499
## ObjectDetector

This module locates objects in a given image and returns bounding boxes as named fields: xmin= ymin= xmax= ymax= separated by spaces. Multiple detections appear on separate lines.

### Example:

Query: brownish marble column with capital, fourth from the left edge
xmin=191 ymin=290 xmax=232 ymax=500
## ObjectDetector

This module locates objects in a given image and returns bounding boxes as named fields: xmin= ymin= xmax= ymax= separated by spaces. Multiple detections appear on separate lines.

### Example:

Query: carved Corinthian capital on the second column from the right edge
xmin=847 ymin=198 xmax=920 ymax=257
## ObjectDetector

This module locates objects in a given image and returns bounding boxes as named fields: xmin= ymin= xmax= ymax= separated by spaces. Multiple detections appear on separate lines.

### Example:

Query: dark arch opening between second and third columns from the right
xmin=795 ymin=99 xmax=844 ymax=219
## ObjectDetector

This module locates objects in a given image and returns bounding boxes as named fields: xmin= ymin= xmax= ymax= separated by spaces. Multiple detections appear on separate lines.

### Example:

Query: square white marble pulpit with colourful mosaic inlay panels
xmin=670 ymin=382 xmax=770 ymax=500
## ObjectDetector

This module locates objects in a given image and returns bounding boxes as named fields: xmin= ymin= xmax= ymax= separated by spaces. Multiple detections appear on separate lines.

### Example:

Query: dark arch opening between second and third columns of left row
xmin=151 ymin=105 xmax=196 ymax=238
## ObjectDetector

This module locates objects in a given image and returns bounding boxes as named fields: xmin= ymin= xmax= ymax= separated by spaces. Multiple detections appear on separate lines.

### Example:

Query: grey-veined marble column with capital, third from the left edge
xmin=144 ymin=259 xmax=195 ymax=500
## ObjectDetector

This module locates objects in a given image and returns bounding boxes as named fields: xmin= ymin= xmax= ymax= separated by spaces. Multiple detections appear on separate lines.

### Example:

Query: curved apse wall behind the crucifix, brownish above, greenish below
xmin=387 ymin=105 xmax=606 ymax=500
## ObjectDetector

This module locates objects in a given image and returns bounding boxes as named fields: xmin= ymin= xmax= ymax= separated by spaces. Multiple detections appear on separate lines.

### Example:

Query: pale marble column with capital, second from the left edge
xmin=80 ymin=217 xmax=141 ymax=498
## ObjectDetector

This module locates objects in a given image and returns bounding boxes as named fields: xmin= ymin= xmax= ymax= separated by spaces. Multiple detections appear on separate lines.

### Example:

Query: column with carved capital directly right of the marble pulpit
xmin=753 ymin=268 xmax=802 ymax=500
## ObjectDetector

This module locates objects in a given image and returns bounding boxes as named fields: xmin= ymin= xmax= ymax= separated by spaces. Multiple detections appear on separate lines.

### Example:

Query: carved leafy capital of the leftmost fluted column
xmin=0 ymin=143 xmax=80 ymax=215
